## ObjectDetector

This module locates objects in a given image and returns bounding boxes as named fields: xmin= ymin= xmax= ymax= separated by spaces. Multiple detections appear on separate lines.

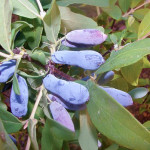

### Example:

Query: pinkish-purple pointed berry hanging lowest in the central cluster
xmin=49 ymin=101 xmax=75 ymax=132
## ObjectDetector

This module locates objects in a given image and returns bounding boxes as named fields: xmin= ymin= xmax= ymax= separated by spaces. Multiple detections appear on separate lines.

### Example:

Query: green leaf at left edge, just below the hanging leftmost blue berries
xmin=0 ymin=108 xmax=23 ymax=133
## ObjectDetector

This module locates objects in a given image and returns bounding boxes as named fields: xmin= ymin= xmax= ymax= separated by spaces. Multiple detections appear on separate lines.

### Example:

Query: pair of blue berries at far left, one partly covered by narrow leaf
xmin=0 ymin=59 xmax=28 ymax=117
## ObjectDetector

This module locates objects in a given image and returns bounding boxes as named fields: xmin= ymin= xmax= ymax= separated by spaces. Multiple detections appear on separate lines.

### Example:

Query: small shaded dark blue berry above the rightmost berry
xmin=97 ymin=71 xmax=114 ymax=85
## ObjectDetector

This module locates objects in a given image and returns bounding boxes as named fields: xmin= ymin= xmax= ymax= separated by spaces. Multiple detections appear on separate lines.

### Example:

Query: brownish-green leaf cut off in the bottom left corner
xmin=0 ymin=119 xmax=17 ymax=150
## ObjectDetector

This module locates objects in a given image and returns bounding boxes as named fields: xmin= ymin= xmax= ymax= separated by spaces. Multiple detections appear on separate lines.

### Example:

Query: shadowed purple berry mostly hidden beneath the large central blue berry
xmin=48 ymin=94 xmax=86 ymax=110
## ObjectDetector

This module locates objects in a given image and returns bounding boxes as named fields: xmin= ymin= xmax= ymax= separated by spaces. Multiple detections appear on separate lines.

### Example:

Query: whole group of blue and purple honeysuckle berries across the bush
xmin=0 ymin=29 xmax=133 ymax=132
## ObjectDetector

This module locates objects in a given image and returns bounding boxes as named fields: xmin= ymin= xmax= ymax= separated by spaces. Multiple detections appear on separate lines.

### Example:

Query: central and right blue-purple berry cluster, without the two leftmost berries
xmin=43 ymin=29 xmax=132 ymax=132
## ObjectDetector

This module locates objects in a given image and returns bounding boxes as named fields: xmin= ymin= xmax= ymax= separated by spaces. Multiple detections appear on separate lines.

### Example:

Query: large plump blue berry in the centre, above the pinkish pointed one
xmin=43 ymin=74 xmax=89 ymax=105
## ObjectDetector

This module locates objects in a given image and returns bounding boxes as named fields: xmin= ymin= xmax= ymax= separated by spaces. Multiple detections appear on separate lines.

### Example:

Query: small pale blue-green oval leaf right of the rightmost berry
xmin=129 ymin=87 xmax=149 ymax=99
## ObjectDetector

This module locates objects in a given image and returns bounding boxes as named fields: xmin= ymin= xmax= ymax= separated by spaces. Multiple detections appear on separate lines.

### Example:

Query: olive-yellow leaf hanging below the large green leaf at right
xmin=121 ymin=59 xmax=143 ymax=86
